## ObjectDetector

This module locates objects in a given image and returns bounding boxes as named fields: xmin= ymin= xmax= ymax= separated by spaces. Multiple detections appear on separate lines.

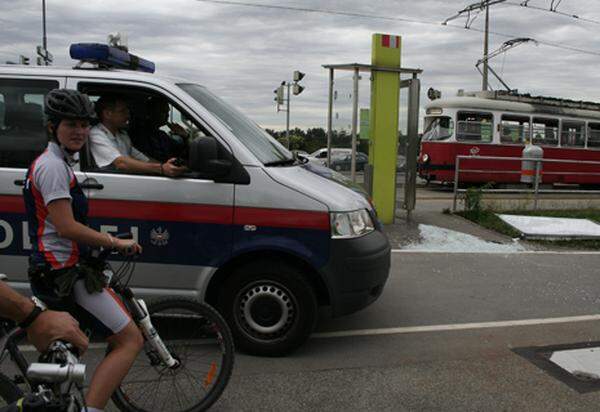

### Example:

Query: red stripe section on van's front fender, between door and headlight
xmin=234 ymin=207 xmax=329 ymax=230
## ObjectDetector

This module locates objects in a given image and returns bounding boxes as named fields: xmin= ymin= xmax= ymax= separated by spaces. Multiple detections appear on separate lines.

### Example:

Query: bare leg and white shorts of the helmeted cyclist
xmin=73 ymin=280 xmax=144 ymax=409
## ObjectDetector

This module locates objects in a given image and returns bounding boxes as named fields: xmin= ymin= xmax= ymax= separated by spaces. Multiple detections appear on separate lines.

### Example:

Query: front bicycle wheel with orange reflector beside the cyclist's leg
xmin=112 ymin=298 xmax=235 ymax=412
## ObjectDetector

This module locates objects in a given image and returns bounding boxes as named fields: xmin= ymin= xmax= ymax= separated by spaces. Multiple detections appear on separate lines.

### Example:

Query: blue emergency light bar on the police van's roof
xmin=69 ymin=43 xmax=155 ymax=73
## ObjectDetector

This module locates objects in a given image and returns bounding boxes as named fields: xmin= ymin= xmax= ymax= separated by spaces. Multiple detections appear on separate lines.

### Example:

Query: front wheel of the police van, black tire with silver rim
xmin=219 ymin=260 xmax=317 ymax=356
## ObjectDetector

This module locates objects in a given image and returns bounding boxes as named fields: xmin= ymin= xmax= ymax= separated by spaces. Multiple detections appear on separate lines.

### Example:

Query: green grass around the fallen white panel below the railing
xmin=457 ymin=209 xmax=600 ymax=249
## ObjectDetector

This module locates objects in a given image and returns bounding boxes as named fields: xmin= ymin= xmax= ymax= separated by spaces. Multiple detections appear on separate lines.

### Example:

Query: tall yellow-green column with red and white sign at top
xmin=369 ymin=34 xmax=401 ymax=223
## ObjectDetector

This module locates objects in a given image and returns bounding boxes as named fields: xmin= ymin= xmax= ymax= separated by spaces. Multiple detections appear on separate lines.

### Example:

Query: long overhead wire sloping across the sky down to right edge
xmin=196 ymin=0 xmax=600 ymax=56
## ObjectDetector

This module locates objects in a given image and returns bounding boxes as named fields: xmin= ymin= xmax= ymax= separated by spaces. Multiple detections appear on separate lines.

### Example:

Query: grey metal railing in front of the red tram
xmin=452 ymin=156 xmax=600 ymax=212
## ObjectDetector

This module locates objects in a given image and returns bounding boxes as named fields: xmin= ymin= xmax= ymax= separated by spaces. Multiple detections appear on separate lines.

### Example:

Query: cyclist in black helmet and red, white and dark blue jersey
xmin=23 ymin=89 xmax=144 ymax=412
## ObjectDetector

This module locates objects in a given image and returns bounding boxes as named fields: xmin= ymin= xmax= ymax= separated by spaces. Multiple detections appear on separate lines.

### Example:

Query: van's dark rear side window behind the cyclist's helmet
xmin=0 ymin=79 xmax=58 ymax=168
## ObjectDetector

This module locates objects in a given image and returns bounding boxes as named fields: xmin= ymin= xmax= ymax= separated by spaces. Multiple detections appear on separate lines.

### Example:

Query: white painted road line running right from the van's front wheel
xmin=311 ymin=315 xmax=600 ymax=338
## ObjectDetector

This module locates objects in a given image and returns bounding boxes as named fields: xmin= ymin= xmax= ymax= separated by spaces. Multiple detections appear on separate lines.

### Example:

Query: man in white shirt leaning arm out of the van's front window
xmin=90 ymin=95 xmax=186 ymax=177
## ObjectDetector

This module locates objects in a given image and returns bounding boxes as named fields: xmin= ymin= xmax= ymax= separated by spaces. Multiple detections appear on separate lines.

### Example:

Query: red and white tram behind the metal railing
xmin=418 ymin=91 xmax=600 ymax=185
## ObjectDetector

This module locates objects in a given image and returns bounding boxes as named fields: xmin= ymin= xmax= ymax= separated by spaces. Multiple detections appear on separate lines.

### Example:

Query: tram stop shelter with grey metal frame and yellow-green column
xmin=323 ymin=62 xmax=423 ymax=223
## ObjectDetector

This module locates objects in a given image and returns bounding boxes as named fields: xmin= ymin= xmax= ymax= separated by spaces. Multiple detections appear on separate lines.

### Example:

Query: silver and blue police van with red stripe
xmin=0 ymin=44 xmax=390 ymax=356
